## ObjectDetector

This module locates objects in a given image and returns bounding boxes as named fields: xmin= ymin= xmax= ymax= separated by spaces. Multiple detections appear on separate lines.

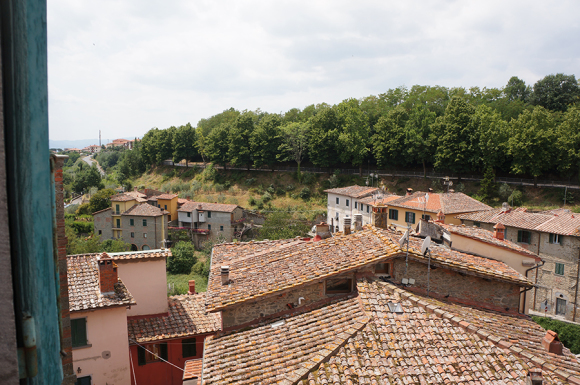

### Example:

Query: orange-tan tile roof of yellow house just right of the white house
xmin=389 ymin=191 xmax=491 ymax=215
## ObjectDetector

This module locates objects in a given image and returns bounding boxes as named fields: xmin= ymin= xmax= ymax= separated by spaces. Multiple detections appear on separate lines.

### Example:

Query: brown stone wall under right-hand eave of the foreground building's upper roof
xmin=393 ymin=258 xmax=520 ymax=312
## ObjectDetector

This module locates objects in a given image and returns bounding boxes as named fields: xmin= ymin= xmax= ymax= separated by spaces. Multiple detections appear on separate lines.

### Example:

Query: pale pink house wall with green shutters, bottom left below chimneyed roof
xmin=71 ymin=306 xmax=130 ymax=385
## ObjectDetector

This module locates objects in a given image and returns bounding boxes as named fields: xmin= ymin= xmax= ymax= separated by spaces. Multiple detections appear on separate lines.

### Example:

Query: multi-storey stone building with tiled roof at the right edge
xmin=458 ymin=204 xmax=580 ymax=321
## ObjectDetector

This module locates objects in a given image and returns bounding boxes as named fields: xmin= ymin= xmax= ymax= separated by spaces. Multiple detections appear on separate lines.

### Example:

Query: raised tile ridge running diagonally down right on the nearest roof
xmin=393 ymin=286 xmax=580 ymax=383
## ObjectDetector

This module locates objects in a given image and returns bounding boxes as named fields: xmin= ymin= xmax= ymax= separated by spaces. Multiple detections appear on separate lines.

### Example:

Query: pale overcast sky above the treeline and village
xmin=48 ymin=0 xmax=580 ymax=140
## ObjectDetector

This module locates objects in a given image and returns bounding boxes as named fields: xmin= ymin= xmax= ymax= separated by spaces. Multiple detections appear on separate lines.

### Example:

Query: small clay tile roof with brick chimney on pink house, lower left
xmin=66 ymin=254 xmax=135 ymax=311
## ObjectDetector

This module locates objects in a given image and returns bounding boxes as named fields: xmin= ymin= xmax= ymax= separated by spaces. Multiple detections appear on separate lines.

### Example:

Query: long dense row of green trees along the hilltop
xmin=130 ymin=74 xmax=580 ymax=184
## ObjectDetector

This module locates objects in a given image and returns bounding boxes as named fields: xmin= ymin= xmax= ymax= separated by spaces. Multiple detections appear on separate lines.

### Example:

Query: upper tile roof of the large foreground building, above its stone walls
xmin=207 ymin=226 xmax=533 ymax=311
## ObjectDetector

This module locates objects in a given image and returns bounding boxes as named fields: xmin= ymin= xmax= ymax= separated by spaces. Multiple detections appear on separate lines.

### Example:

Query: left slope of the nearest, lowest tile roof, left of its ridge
xmin=203 ymin=292 xmax=368 ymax=385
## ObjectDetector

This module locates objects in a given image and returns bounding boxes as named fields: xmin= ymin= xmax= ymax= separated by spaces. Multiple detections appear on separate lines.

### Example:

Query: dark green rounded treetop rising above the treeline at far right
xmin=532 ymin=74 xmax=580 ymax=111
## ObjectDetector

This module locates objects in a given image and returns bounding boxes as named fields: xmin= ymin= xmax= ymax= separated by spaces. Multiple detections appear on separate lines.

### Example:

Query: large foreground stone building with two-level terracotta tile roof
xmin=202 ymin=227 xmax=580 ymax=385
